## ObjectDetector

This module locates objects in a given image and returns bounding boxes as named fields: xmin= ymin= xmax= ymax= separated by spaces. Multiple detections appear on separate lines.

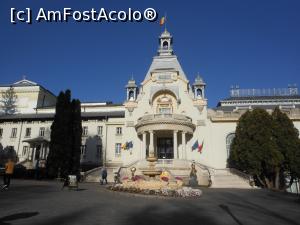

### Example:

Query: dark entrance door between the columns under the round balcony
xmin=157 ymin=138 xmax=174 ymax=159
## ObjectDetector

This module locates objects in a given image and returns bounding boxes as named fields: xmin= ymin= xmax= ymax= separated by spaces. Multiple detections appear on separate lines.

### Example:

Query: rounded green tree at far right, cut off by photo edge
xmin=272 ymin=107 xmax=300 ymax=189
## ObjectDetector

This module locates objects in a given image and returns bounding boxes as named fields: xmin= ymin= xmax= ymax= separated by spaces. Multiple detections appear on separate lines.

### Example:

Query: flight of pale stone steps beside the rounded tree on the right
xmin=211 ymin=169 xmax=253 ymax=189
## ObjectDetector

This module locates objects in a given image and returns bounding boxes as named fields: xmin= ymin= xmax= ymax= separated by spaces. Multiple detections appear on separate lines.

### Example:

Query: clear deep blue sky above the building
xmin=0 ymin=0 xmax=300 ymax=107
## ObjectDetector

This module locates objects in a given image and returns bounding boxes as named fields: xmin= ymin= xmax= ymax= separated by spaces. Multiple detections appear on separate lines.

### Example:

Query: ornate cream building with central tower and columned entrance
xmin=0 ymin=30 xmax=300 ymax=187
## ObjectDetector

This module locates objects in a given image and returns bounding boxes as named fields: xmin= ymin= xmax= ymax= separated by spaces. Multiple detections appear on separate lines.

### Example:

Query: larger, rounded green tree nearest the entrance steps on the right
xmin=229 ymin=109 xmax=284 ymax=188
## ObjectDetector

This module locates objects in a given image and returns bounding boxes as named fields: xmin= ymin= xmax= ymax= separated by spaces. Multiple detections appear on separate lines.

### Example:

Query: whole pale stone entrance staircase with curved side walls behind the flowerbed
xmin=85 ymin=159 xmax=252 ymax=189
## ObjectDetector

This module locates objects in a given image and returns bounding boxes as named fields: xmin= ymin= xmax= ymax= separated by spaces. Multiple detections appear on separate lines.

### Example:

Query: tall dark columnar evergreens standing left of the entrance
xmin=47 ymin=90 xmax=82 ymax=177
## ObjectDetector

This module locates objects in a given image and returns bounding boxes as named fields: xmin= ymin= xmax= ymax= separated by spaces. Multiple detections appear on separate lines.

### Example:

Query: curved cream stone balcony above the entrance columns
xmin=135 ymin=114 xmax=196 ymax=134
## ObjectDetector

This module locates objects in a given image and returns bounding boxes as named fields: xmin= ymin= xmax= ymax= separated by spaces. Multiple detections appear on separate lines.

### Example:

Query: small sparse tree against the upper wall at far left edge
xmin=1 ymin=86 xmax=18 ymax=115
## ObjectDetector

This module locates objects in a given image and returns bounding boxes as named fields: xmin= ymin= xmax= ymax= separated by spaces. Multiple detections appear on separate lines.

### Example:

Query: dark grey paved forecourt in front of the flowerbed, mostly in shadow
xmin=0 ymin=180 xmax=300 ymax=225
